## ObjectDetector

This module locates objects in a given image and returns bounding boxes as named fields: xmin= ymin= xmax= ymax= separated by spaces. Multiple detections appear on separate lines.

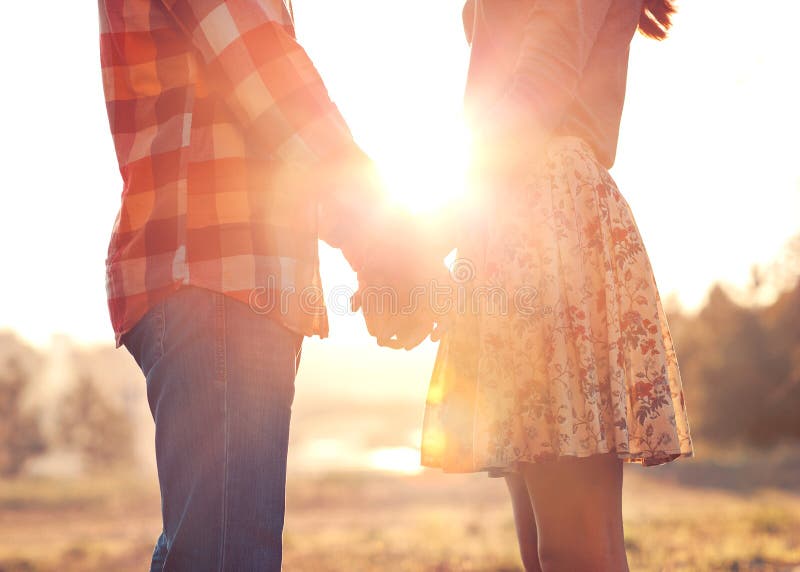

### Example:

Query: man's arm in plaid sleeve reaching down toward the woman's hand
xmin=161 ymin=0 xmax=382 ymax=267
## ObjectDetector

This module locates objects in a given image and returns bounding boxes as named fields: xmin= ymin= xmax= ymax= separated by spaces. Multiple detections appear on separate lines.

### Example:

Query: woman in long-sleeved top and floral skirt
xmin=423 ymin=0 xmax=692 ymax=572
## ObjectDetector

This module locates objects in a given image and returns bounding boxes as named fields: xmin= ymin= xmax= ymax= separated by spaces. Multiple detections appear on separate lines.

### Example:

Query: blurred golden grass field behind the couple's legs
xmin=0 ymin=461 xmax=800 ymax=572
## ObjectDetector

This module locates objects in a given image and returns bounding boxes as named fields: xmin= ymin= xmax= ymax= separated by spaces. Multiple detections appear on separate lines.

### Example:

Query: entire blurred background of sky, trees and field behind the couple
xmin=0 ymin=0 xmax=800 ymax=572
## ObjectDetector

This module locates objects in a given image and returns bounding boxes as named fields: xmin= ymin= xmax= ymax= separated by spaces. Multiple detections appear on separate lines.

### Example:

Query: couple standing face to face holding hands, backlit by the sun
xmin=99 ymin=0 xmax=692 ymax=572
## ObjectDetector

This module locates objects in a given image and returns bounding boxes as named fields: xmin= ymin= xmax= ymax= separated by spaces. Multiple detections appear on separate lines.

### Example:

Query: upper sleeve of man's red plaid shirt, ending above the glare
xmin=162 ymin=0 xmax=354 ymax=166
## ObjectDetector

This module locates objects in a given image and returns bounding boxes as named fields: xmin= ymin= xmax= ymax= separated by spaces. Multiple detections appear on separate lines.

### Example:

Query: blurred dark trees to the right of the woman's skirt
xmin=668 ymin=235 xmax=800 ymax=447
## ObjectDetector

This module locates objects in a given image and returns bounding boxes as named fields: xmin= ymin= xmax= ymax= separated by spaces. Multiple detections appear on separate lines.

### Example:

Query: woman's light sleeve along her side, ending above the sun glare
xmin=500 ymin=0 xmax=612 ymax=135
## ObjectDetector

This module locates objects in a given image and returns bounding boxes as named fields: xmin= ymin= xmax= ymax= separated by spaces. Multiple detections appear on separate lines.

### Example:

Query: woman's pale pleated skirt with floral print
xmin=422 ymin=137 xmax=692 ymax=474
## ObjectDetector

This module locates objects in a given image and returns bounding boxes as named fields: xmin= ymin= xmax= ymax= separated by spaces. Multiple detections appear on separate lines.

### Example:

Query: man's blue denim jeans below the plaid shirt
xmin=122 ymin=287 xmax=302 ymax=572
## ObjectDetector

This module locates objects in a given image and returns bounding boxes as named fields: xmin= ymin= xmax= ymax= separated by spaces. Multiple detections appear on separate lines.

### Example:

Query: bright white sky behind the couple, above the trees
xmin=0 ymin=0 xmax=800 ymax=343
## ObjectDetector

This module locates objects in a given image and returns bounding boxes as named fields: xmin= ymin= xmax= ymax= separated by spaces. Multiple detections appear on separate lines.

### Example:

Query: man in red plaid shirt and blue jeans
xmin=99 ymin=0 xmax=432 ymax=572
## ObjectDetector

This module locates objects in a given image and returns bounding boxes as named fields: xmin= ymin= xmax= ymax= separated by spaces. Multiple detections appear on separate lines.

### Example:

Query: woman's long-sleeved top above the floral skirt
xmin=464 ymin=0 xmax=642 ymax=167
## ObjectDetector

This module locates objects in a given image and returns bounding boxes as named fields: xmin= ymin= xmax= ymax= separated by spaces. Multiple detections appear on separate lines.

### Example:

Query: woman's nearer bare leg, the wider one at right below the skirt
xmin=521 ymin=454 xmax=628 ymax=572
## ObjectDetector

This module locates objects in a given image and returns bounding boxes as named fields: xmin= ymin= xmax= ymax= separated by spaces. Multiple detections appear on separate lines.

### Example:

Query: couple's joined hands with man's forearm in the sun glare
xmin=313 ymin=147 xmax=460 ymax=350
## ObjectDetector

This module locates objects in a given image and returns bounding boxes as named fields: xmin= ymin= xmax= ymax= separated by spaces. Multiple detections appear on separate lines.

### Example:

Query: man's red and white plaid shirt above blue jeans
xmin=99 ymin=0 xmax=374 ymax=346
